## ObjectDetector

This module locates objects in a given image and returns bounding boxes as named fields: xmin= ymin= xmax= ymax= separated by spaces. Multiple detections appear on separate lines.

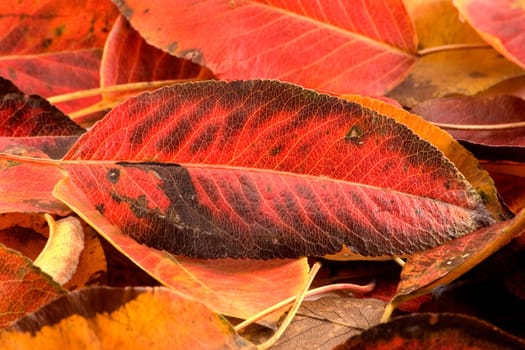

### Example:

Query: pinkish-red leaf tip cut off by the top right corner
xmin=453 ymin=0 xmax=525 ymax=68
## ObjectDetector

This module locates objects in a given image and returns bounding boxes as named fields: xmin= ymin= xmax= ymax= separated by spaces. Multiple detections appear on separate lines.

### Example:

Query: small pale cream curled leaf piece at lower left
xmin=34 ymin=214 xmax=84 ymax=285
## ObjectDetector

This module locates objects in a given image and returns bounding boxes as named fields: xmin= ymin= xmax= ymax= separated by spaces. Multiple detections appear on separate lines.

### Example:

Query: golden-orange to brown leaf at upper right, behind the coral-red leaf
xmin=389 ymin=0 xmax=523 ymax=107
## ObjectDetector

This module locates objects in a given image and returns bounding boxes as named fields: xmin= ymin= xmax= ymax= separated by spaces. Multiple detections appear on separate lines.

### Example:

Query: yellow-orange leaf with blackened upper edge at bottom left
xmin=0 ymin=287 xmax=254 ymax=350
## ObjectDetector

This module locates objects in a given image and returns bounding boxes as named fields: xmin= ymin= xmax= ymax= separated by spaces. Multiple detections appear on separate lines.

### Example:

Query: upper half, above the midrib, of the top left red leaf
xmin=0 ymin=0 xmax=117 ymax=55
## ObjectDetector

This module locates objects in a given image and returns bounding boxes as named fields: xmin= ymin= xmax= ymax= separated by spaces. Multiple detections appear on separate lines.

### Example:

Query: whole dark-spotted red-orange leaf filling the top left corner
xmin=0 ymin=0 xmax=118 ymax=112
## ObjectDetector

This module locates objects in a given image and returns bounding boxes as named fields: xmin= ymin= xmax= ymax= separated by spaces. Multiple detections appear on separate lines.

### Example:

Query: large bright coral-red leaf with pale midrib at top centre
xmin=114 ymin=0 xmax=416 ymax=95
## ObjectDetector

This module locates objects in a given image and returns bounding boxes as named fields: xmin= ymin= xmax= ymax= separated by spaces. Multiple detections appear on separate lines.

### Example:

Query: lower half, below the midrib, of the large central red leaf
xmin=66 ymin=163 xmax=490 ymax=259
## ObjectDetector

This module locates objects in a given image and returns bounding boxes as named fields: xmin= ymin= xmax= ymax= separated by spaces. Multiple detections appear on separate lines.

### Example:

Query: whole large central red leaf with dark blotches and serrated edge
xmin=64 ymin=81 xmax=492 ymax=258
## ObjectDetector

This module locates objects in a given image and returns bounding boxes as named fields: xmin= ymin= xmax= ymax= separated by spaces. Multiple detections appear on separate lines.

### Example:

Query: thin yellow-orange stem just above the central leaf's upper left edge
xmin=47 ymin=79 xmax=191 ymax=104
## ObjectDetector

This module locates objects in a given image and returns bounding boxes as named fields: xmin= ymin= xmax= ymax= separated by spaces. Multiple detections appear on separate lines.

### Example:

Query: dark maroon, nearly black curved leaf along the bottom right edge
xmin=334 ymin=313 xmax=525 ymax=350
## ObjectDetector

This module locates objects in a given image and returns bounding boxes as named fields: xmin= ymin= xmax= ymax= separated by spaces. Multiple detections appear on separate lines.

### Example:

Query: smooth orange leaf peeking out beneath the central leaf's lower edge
xmin=54 ymin=179 xmax=308 ymax=321
